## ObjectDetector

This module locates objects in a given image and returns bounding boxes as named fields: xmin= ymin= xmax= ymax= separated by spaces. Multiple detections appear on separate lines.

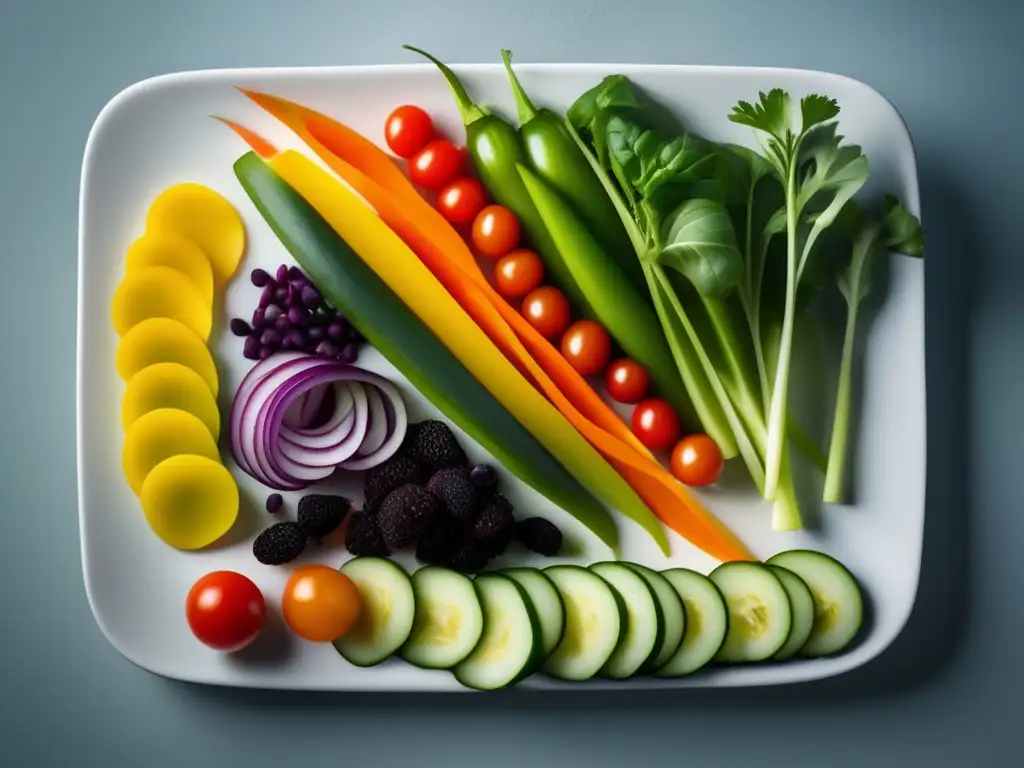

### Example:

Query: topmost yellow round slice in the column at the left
xmin=145 ymin=182 xmax=246 ymax=285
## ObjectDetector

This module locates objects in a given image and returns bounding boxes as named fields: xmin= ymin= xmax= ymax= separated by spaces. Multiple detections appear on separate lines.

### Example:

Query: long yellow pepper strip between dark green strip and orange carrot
xmin=268 ymin=150 xmax=669 ymax=554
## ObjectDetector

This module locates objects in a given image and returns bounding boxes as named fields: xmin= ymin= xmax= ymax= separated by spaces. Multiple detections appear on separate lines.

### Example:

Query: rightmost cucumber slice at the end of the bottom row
xmin=768 ymin=550 xmax=864 ymax=658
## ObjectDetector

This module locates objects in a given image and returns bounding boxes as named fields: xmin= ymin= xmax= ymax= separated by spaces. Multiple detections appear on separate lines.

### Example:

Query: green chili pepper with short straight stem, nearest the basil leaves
xmin=502 ymin=48 xmax=650 ymax=302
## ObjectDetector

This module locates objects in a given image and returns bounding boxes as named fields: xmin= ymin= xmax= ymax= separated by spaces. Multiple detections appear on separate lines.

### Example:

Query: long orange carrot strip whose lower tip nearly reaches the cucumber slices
xmin=228 ymin=105 xmax=755 ymax=561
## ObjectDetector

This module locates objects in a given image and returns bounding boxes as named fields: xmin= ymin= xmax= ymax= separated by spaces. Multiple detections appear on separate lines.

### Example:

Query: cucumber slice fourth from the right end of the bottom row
xmin=654 ymin=568 xmax=729 ymax=678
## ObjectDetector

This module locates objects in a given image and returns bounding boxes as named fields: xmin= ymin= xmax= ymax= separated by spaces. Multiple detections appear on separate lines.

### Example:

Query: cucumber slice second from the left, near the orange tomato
xmin=399 ymin=565 xmax=483 ymax=670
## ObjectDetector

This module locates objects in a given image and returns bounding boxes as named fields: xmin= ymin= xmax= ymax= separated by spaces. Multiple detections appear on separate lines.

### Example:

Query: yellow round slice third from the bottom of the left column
xmin=121 ymin=362 xmax=220 ymax=440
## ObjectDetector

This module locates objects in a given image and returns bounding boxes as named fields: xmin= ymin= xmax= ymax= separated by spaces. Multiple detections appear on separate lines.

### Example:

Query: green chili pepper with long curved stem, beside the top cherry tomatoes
xmin=403 ymin=45 xmax=594 ymax=317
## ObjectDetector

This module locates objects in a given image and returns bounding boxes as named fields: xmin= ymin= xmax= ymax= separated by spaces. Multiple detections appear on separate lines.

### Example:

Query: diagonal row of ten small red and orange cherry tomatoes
xmin=384 ymin=104 xmax=724 ymax=485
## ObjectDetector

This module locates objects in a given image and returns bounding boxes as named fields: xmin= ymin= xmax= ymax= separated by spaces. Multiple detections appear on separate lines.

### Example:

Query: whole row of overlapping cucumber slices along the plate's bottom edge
xmin=334 ymin=550 xmax=863 ymax=690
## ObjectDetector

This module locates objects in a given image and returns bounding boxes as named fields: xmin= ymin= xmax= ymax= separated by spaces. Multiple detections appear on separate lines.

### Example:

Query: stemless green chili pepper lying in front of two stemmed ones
xmin=518 ymin=165 xmax=692 ymax=421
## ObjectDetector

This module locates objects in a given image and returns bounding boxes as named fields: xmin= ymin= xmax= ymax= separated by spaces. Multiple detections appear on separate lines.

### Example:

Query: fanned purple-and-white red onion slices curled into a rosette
xmin=230 ymin=352 xmax=408 ymax=490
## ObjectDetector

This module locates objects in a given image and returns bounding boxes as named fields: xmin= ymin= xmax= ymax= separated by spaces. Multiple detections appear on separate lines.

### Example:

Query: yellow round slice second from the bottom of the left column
xmin=121 ymin=408 xmax=220 ymax=496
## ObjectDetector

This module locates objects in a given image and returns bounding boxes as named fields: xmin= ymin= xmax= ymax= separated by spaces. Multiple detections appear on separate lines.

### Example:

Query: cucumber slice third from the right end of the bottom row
xmin=710 ymin=561 xmax=793 ymax=663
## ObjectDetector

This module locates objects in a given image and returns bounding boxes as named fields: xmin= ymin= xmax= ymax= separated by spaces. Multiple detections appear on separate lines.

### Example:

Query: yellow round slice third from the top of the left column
xmin=111 ymin=266 xmax=213 ymax=343
